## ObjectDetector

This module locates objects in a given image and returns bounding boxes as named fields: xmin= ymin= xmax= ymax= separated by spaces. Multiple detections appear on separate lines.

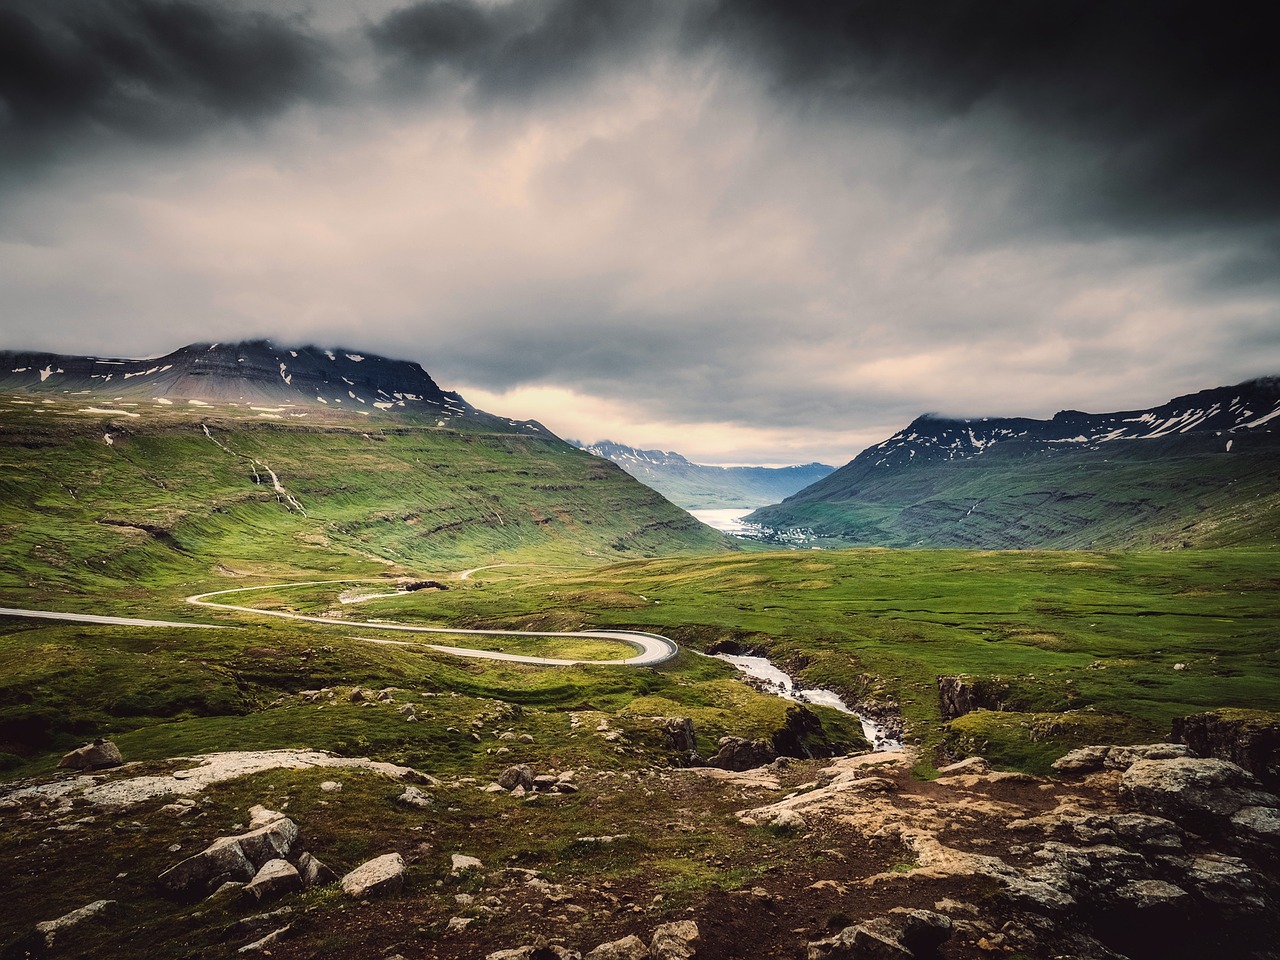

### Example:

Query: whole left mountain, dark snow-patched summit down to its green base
xmin=0 ymin=340 xmax=728 ymax=594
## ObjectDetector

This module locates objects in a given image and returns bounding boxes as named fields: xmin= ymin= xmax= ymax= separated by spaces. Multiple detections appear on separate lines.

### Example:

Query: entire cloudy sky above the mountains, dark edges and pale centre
xmin=0 ymin=0 xmax=1280 ymax=465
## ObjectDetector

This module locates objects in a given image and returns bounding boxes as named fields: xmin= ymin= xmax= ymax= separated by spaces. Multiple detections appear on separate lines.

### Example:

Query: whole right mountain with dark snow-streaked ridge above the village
xmin=748 ymin=378 xmax=1280 ymax=549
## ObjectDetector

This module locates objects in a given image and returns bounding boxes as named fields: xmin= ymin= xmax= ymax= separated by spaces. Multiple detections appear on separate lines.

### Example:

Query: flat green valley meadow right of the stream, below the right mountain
xmin=335 ymin=549 xmax=1280 ymax=769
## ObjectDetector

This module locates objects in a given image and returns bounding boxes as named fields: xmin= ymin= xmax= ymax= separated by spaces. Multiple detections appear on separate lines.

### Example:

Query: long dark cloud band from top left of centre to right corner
xmin=370 ymin=0 xmax=1280 ymax=230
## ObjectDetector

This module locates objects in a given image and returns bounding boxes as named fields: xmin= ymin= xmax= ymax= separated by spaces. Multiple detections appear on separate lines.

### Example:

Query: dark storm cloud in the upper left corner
xmin=0 ymin=0 xmax=335 ymax=165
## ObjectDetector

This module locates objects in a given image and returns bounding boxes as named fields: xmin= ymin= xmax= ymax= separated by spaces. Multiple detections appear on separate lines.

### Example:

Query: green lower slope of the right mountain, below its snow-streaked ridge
xmin=751 ymin=434 xmax=1280 ymax=549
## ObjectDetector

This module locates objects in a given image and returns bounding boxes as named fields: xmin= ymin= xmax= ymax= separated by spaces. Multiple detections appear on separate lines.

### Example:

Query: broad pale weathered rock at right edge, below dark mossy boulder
xmin=1120 ymin=756 xmax=1280 ymax=829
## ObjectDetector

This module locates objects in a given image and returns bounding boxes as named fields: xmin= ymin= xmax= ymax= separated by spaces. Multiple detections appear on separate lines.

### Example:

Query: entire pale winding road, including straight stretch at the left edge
xmin=0 ymin=578 xmax=680 ymax=667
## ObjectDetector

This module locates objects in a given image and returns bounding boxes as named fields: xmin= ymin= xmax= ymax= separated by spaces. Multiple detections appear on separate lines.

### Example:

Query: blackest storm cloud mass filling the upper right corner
xmin=700 ymin=0 xmax=1280 ymax=236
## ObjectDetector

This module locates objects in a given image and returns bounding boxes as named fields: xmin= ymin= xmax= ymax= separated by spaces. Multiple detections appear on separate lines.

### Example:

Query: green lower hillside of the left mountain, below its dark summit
xmin=0 ymin=397 xmax=727 ymax=608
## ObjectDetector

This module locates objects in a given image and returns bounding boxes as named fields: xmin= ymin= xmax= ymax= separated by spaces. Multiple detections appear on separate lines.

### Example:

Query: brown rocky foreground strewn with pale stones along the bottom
xmin=0 ymin=744 xmax=1280 ymax=960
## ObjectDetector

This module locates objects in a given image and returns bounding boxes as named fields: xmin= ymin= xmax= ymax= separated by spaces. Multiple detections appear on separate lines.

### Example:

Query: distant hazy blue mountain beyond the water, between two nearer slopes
xmin=571 ymin=440 xmax=835 ymax=509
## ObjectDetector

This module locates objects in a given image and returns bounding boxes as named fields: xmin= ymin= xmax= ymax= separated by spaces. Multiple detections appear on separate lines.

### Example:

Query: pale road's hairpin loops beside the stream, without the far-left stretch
xmin=187 ymin=571 xmax=680 ymax=667
